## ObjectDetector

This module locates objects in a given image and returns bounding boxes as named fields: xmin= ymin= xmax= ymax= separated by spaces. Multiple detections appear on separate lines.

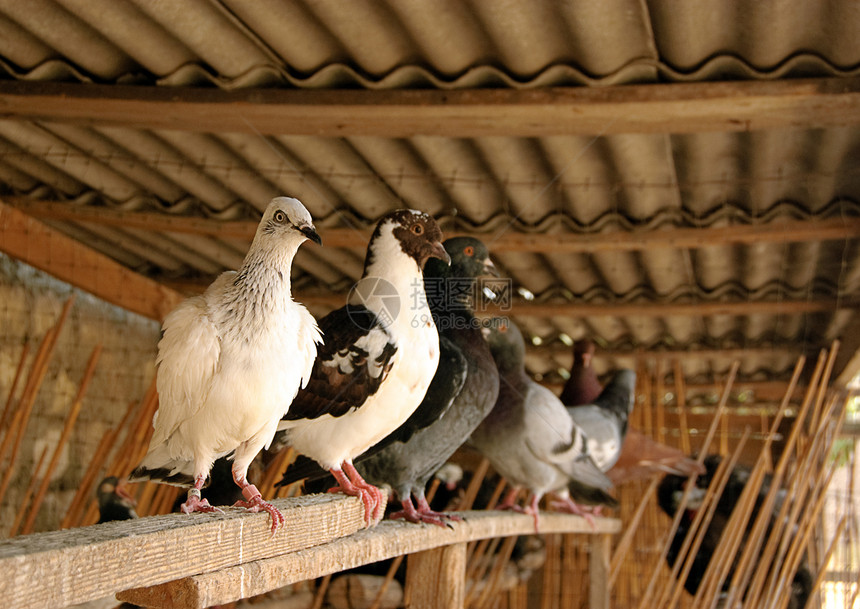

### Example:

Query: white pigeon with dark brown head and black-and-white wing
xmin=280 ymin=210 xmax=450 ymax=526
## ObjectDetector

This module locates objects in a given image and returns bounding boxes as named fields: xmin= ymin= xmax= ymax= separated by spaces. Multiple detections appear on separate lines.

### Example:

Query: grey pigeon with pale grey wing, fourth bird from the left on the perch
xmin=471 ymin=318 xmax=617 ymax=528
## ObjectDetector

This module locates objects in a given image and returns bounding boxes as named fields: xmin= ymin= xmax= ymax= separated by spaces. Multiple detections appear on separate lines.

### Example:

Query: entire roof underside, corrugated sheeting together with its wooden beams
xmin=0 ymin=0 xmax=860 ymax=396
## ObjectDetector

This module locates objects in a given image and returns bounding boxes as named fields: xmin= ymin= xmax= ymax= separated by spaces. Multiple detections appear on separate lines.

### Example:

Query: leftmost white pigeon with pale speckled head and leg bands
xmin=130 ymin=197 xmax=322 ymax=533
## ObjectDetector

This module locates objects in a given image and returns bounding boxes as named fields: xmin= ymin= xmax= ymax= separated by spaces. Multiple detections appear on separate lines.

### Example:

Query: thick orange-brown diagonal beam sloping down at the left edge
xmin=0 ymin=201 xmax=184 ymax=321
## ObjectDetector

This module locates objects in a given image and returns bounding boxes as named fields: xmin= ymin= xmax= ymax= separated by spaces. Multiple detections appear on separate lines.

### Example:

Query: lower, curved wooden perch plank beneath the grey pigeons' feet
xmin=117 ymin=511 xmax=621 ymax=609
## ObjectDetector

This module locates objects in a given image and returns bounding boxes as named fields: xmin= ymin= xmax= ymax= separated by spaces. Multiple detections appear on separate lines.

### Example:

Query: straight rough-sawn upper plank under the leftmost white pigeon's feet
xmin=0 ymin=494 xmax=364 ymax=609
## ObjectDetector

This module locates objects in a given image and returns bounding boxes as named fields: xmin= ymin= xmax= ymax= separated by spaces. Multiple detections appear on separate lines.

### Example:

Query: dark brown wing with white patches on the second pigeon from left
xmin=284 ymin=305 xmax=397 ymax=421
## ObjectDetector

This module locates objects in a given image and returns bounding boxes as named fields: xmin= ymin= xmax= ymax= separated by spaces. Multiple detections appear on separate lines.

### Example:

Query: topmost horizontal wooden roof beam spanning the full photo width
xmin=0 ymin=78 xmax=860 ymax=138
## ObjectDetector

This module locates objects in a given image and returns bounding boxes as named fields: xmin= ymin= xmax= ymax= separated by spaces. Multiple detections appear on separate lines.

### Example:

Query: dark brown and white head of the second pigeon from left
xmin=364 ymin=209 xmax=451 ymax=273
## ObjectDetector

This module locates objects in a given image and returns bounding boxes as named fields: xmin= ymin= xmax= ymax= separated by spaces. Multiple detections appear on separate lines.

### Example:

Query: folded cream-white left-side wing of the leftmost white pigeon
xmin=151 ymin=296 xmax=221 ymax=446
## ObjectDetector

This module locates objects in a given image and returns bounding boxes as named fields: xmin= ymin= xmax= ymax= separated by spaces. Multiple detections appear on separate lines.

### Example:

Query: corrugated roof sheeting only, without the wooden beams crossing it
xmin=0 ymin=0 xmax=860 ymax=390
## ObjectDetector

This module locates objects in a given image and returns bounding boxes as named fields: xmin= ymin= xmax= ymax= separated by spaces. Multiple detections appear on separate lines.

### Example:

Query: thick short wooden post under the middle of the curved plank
xmin=406 ymin=543 xmax=466 ymax=609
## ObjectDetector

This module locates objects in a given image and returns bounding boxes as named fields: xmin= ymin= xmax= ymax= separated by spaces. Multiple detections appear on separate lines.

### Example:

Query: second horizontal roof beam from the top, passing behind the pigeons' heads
xmin=11 ymin=197 xmax=860 ymax=254
